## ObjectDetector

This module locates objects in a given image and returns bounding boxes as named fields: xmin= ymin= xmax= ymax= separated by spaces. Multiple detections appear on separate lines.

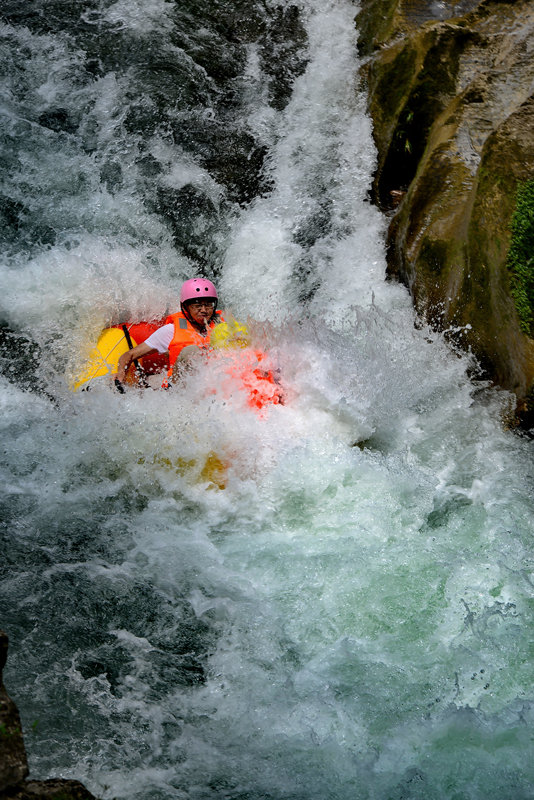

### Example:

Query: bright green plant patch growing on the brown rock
xmin=507 ymin=180 xmax=534 ymax=337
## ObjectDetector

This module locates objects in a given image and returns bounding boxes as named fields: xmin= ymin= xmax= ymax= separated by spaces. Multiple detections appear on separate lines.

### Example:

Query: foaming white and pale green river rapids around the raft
xmin=0 ymin=0 xmax=534 ymax=800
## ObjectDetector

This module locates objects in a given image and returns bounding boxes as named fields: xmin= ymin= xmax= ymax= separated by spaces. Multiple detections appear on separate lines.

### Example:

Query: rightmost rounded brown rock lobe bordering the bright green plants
xmin=453 ymin=100 xmax=534 ymax=398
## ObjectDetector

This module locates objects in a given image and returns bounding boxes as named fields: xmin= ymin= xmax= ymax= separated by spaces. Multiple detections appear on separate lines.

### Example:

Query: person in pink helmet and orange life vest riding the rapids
xmin=113 ymin=278 xmax=224 ymax=388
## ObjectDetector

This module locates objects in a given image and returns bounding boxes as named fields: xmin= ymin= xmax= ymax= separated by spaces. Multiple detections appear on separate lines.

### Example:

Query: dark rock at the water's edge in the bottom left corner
xmin=0 ymin=631 xmax=100 ymax=800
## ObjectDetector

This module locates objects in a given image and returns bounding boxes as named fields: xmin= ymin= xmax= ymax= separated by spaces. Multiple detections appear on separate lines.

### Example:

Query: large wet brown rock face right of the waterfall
xmin=362 ymin=0 xmax=534 ymax=416
